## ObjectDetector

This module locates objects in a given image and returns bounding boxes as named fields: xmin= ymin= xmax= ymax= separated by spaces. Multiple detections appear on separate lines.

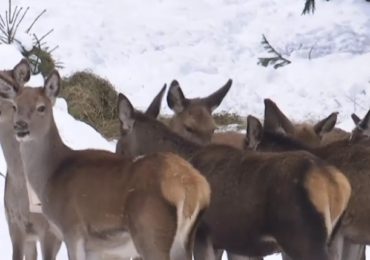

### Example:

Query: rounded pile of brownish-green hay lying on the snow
xmin=60 ymin=71 xmax=120 ymax=139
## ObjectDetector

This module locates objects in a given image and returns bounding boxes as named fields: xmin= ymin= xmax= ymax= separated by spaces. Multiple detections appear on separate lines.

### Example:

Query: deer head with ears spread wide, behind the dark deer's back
xmin=167 ymin=79 xmax=232 ymax=144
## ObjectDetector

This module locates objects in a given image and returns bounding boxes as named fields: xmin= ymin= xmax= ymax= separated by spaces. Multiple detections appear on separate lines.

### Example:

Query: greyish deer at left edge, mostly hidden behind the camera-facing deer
xmin=0 ymin=60 xmax=61 ymax=260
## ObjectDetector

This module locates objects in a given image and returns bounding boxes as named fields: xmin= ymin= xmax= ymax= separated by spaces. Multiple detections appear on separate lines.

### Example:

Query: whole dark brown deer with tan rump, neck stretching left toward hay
xmin=115 ymin=94 xmax=350 ymax=260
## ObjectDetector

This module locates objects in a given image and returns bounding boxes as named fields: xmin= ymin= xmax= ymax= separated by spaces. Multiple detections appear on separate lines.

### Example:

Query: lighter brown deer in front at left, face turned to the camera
xmin=0 ymin=68 xmax=210 ymax=260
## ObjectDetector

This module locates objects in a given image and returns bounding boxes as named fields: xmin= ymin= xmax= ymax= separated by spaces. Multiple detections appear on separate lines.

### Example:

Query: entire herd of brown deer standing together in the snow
xmin=0 ymin=60 xmax=370 ymax=260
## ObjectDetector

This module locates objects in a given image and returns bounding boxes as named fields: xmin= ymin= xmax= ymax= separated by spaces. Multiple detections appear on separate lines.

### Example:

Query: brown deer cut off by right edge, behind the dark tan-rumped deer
xmin=247 ymin=99 xmax=370 ymax=260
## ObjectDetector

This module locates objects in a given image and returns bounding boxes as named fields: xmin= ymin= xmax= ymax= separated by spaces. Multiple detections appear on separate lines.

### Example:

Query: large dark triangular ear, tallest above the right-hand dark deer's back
xmin=263 ymin=98 xmax=294 ymax=135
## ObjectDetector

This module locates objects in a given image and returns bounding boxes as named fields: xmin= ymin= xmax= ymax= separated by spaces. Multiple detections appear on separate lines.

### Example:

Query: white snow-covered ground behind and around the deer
xmin=0 ymin=0 xmax=370 ymax=260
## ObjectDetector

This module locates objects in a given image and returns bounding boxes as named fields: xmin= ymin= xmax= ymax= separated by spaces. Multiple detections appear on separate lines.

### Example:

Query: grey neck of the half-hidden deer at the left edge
xmin=0 ymin=121 xmax=24 ymax=180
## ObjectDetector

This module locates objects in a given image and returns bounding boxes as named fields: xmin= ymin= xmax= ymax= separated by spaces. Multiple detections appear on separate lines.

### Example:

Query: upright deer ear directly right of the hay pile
xmin=118 ymin=93 xmax=135 ymax=133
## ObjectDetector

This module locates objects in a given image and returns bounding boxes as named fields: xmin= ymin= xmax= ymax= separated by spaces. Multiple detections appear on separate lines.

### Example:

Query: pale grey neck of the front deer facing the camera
xmin=20 ymin=116 xmax=72 ymax=202
